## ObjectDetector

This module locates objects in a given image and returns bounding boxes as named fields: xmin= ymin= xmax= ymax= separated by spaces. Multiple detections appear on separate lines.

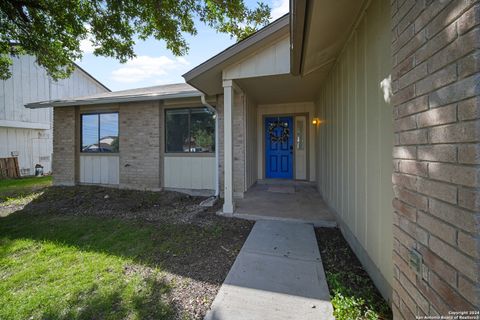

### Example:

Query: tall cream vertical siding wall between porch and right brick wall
xmin=316 ymin=0 xmax=394 ymax=295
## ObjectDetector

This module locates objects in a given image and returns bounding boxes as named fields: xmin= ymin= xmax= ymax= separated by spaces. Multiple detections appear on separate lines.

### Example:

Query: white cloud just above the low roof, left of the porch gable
xmin=111 ymin=56 xmax=189 ymax=83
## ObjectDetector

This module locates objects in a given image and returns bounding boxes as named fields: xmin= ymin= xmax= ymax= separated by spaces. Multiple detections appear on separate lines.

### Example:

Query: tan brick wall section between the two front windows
xmin=119 ymin=101 xmax=164 ymax=190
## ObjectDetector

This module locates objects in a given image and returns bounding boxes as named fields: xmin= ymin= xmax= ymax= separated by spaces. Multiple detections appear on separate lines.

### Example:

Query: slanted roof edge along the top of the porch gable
xmin=182 ymin=13 xmax=289 ymax=95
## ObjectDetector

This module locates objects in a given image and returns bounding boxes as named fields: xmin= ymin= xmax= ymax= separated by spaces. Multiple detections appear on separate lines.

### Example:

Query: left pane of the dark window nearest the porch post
xmin=166 ymin=109 xmax=190 ymax=152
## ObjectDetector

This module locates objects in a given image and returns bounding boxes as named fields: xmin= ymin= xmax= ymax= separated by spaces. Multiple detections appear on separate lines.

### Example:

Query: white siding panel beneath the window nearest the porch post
xmin=164 ymin=156 xmax=215 ymax=190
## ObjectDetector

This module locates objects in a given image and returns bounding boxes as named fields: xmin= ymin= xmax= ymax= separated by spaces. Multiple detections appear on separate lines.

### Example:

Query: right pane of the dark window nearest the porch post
xmin=190 ymin=108 xmax=215 ymax=152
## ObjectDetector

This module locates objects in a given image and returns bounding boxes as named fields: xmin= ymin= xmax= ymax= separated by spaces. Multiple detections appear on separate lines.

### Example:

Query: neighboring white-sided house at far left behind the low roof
xmin=0 ymin=55 xmax=110 ymax=175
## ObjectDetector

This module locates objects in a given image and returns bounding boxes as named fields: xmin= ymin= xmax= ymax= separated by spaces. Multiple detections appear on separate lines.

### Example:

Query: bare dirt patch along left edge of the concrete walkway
xmin=155 ymin=210 xmax=253 ymax=319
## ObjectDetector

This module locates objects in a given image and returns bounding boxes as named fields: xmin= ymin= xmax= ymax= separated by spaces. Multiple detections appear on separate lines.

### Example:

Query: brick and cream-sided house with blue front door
xmin=27 ymin=0 xmax=480 ymax=319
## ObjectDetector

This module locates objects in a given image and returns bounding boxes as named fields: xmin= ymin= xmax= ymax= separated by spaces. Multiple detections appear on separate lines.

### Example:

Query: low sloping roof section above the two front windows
xmin=25 ymin=83 xmax=202 ymax=109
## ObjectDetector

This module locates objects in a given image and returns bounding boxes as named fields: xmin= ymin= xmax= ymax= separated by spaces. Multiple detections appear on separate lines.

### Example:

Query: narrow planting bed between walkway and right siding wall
xmin=315 ymin=228 xmax=392 ymax=319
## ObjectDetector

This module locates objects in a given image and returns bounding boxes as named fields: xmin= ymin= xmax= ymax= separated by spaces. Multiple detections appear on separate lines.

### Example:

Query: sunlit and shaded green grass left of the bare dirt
xmin=0 ymin=214 xmax=176 ymax=319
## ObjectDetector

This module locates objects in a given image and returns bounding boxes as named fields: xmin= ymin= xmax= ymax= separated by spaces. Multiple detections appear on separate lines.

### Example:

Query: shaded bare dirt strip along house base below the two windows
xmin=24 ymin=186 xmax=225 ymax=224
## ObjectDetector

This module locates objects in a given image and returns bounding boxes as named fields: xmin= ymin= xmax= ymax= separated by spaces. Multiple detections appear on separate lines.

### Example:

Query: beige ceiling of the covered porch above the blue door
xmin=235 ymin=66 xmax=329 ymax=104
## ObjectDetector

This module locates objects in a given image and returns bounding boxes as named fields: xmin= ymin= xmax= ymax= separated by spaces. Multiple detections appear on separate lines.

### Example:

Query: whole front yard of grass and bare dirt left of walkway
xmin=0 ymin=181 xmax=251 ymax=320
